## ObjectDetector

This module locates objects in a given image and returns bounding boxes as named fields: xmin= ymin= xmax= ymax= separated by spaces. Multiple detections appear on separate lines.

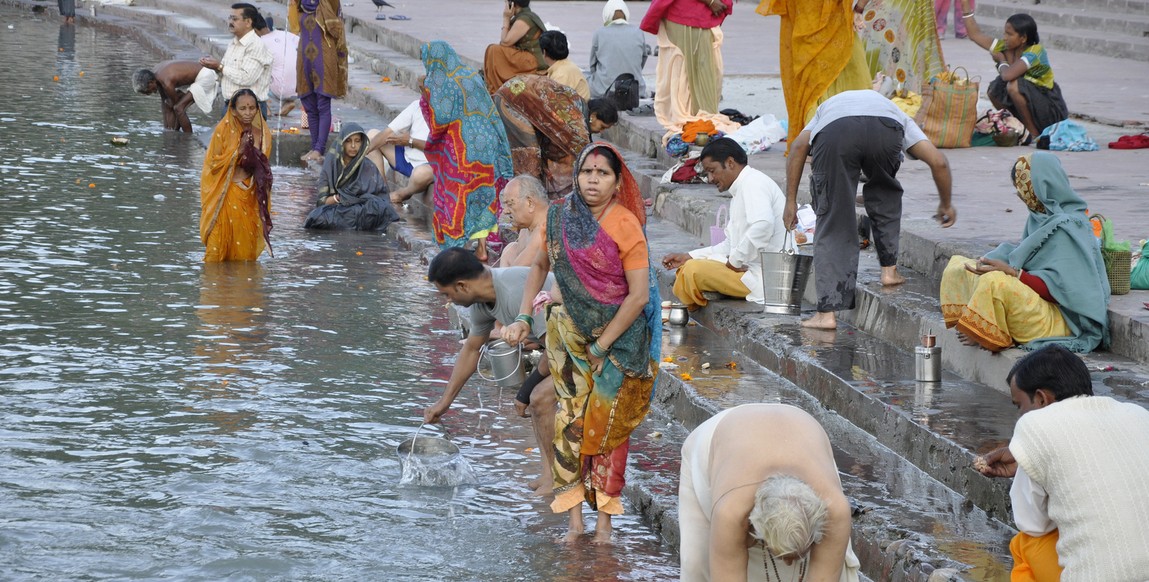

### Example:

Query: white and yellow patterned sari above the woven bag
xmin=858 ymin=0 xmax=956 ymax=94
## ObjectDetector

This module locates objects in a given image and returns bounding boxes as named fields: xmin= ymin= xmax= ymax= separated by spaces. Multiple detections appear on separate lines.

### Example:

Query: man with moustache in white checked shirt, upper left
xmin=200 ymin=3 xmax=272 ymax=118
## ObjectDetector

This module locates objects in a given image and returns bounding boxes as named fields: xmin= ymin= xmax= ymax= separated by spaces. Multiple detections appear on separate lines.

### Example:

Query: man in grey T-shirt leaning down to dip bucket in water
xmin=423 ymin=247 xmax=557 ymax=497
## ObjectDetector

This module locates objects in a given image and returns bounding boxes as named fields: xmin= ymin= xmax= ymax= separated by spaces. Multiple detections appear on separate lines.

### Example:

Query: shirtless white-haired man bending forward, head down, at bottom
xmin=678 ymin=404 xmax=858 ymax=582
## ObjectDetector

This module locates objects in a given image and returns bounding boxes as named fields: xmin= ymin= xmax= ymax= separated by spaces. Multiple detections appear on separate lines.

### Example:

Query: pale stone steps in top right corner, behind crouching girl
xmin=978 ymin=2 xmax=1149 ymax=60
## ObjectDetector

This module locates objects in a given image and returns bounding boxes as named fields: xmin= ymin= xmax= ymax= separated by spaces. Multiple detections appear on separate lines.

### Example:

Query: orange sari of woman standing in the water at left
xmin=200 ymin=108 xmax=271 ymax=263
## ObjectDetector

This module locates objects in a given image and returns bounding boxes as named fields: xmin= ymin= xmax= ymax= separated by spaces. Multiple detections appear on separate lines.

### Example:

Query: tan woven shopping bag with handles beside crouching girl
xmin=918 ymin=67 xmax=979 ymax=148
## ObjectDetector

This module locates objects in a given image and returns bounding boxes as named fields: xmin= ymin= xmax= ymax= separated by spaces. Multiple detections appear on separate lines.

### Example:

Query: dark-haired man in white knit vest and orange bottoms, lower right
xmin=974 ymin=346 xmax=1149 ymax=582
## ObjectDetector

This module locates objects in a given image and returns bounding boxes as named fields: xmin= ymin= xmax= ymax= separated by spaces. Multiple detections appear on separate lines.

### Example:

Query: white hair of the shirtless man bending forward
xmin=750 ymin=475 xmax=826 ymax=558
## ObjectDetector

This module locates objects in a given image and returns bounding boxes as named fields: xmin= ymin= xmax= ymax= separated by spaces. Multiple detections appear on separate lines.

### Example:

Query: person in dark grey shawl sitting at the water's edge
xmin=303 ymin=123 xmax=399 ymax=231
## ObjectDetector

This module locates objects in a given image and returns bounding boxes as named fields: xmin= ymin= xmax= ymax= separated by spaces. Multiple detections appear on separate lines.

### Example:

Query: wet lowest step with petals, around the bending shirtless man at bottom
xmin=627 ymin=325 xmax=1013 ymax=581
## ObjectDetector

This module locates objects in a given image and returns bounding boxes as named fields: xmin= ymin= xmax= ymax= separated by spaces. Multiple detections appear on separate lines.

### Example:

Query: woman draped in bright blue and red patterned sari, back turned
xmin=419 ymin=40 xmax=515 ymax=261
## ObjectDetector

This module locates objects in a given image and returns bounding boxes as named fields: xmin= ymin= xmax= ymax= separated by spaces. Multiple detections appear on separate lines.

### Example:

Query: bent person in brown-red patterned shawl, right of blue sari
xmin=493 ymin=75 xmax=591 ymax=200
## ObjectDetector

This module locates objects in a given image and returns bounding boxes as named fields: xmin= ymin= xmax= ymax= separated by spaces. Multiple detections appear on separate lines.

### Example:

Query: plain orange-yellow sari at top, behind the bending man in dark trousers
xmin=757 ymin=0 xmax=865 ymax=150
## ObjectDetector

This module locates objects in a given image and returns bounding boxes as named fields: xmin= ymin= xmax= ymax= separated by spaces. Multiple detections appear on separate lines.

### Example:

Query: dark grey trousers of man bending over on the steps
xmin=810 ymin=116 xmax=904 ymax=312
